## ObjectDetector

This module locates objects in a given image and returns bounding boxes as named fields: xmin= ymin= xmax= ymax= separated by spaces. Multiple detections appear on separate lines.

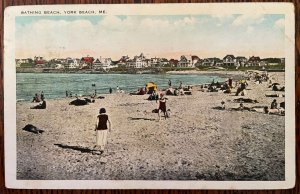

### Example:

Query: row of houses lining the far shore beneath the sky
xmin=16 ymin=53 xmax=284 ymax=70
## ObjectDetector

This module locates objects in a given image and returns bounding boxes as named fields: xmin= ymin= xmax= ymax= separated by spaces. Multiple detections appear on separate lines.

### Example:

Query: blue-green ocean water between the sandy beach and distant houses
xmin=16 ymin=73 xmax=224 ymax=100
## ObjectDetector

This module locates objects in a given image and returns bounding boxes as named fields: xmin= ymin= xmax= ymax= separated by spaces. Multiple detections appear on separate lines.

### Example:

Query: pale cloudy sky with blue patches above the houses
xmin=16 ymin=14 xmax=285 ymax=60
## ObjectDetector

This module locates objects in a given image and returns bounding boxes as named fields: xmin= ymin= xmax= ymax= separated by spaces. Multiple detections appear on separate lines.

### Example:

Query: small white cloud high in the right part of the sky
xmin=232 ymin=14 xmax=265 ymax=26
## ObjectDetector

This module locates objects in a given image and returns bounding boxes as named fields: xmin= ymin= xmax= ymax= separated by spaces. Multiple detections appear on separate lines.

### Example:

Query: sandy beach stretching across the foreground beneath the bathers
xmin=16 ymin=72 xmax=285 ymax=181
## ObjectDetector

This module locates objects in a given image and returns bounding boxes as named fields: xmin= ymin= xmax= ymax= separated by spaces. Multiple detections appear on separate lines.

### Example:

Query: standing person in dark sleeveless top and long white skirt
xmin=94 ymin=108 xmax=111 ymax=152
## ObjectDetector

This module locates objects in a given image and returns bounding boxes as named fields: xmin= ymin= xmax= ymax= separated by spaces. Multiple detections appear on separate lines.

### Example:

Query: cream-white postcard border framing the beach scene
xmin=4 ymin=3 xmax=296 ymax=189
